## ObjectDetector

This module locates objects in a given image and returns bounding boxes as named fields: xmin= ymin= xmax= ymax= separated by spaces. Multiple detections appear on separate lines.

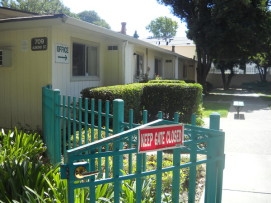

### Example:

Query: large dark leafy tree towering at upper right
xmin=157 ymin=0 xmax=267 ymax=93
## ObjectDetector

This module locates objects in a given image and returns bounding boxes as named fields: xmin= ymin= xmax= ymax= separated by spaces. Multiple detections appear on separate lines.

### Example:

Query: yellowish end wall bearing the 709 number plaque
xmin=0 ymin=27 xmax=51 ymax=128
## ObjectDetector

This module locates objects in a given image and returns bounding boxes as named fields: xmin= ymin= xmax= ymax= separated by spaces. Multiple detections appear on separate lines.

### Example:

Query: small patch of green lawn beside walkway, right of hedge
xmin=203 ymin=101 xmax=231 ymax=118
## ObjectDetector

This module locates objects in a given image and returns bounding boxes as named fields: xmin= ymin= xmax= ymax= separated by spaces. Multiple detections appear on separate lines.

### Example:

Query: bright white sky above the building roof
xmin=62 ymin=0 xmax=186 ymax=39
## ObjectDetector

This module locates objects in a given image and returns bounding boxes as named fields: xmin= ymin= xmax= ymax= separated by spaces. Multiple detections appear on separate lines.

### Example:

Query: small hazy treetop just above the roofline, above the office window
xmin=77 ymin=11 xmax=111 ymax=29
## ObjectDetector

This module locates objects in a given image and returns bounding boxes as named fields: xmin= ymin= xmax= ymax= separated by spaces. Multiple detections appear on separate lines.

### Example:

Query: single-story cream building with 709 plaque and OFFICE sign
xmin=0 ymin=7 xmax=196 ymax=128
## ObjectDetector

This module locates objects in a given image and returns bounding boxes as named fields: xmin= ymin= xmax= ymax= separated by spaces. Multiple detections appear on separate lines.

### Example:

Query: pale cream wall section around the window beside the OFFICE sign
xmin=51 ymin=25 xmax=103 ymax=97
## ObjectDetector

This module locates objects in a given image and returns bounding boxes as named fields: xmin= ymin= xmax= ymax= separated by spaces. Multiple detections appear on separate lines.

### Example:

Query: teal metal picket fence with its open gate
xmin=43 ymin=87 xmax=225 ymax=203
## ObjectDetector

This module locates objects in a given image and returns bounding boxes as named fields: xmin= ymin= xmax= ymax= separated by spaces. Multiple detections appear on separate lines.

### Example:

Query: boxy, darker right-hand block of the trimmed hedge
xmin=141 ymin=83 xmax=202 ymax=123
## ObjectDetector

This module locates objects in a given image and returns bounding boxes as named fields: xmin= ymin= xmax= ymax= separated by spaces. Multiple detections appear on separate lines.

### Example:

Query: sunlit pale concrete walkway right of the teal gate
xmin=202 ymin=90 xmax=271 ymax=203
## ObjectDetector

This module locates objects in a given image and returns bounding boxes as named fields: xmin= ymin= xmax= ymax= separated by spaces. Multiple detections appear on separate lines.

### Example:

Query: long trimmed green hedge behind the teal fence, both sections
xmin=81 ymin=80 xmax=202 ymax=123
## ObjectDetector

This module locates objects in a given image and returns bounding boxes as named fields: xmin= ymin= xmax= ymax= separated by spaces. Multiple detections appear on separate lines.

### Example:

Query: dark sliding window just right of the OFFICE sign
xmin=72 ymin=43 xmax=99 ymax=76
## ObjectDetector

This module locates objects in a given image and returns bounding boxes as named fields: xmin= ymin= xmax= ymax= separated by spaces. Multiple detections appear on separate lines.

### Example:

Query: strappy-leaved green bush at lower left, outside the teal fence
xmin=0 ymin=129 xmax=66 ymax=202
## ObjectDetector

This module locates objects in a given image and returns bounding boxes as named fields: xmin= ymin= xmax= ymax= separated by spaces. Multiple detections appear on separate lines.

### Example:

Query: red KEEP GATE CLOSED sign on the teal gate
xmin=138 ymin=124 xmax=184 ymax=153
